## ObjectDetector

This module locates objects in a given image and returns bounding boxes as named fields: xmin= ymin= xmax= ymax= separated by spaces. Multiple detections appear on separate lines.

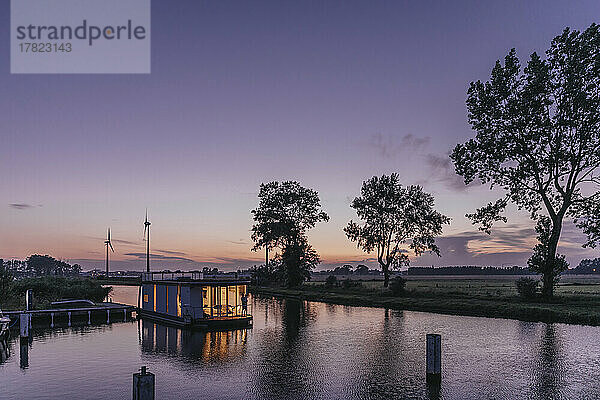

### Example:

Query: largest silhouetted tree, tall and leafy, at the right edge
xmin=451 ymin=24 xmax=600 ymax=297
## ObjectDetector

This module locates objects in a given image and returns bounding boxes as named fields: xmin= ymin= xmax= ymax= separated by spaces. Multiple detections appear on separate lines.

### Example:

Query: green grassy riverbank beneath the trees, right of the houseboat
xmin=251 ymin=277 xmax=600 ymax=326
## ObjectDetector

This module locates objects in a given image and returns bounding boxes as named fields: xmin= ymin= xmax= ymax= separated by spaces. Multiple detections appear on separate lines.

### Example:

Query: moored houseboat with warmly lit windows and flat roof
xmin=139 ymin=272 xmax=252 ymax=328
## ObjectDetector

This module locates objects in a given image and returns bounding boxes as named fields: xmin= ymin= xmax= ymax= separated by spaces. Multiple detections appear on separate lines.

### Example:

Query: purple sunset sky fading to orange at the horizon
xmin=0 ymin=0 xmax=600 ymax=270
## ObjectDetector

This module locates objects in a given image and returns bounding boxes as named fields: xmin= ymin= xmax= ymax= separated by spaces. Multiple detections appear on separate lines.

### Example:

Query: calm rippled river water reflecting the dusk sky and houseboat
xmin=0 ymin=288 xmax=600 ymax=400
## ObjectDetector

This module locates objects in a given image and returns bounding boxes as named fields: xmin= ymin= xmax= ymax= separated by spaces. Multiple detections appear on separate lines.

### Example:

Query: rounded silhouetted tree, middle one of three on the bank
xmin=344 ymin=173 xmax=450 ymax=287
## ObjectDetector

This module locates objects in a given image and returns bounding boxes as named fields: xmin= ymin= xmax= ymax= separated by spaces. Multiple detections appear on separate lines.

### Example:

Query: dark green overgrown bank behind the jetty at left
xmin=0 ymin=276 xmax=112 ymax=311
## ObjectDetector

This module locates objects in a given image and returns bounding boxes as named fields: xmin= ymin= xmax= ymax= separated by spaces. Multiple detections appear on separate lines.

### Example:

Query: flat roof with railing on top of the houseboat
xmin=142 ymin=271 xmax=250 ymax=286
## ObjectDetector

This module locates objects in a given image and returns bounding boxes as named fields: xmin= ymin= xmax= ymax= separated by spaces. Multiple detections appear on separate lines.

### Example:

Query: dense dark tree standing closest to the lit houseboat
xmin=251 ymin=181 xmax=329 ymax=286
